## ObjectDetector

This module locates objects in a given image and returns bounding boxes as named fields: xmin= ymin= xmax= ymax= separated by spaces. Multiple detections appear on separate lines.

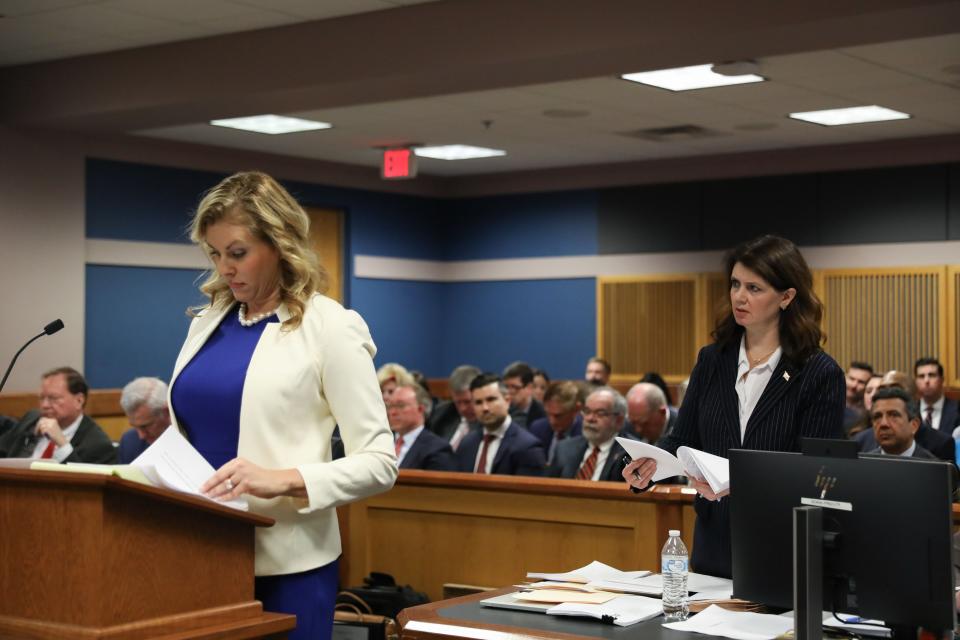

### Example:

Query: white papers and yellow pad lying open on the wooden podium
xmin=30 ymin=428 xmax=249 ymax=511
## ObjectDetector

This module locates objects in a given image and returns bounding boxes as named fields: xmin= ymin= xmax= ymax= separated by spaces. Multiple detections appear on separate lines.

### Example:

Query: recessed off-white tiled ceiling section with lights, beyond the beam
xmin=139 ymin=34 xmax=960 ymax=176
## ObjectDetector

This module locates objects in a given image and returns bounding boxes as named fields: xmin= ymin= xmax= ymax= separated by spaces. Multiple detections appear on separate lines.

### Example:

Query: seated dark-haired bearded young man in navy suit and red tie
xmin=456 ymin=373 xmax=546 ymax=476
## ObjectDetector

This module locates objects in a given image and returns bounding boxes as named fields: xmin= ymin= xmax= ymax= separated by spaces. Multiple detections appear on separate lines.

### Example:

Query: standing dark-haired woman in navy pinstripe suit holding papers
xmin=623 ymin=236 xmax=845 ymax=577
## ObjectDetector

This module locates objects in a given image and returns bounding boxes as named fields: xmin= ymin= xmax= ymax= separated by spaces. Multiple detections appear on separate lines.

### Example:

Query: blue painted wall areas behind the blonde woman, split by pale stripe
xmin=85 ymin=159 xmax=597 ymax=387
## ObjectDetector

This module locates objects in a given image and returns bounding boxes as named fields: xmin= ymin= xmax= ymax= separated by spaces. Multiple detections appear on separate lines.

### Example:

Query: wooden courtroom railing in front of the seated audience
xmin=340 ymin=470 xmax=695 ymax=599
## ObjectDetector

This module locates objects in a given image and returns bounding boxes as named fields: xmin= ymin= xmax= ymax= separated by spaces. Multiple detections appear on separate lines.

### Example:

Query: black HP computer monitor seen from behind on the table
xmin=729 ymin=449 xmax=955 ymax=631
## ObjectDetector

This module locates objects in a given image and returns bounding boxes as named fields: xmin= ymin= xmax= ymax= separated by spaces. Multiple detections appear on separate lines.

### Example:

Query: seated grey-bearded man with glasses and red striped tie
xmin=547 ymin=387 xmax=632 ymax=482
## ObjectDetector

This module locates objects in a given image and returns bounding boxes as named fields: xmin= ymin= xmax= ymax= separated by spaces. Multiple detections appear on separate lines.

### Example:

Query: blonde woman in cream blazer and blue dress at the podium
xmin=170 ymin=172 xmax=397 ymax=638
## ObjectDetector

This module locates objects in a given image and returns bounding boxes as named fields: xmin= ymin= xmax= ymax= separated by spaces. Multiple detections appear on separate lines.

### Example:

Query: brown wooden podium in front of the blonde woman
xmin=0 ymin=468 xmax=296 ymax=640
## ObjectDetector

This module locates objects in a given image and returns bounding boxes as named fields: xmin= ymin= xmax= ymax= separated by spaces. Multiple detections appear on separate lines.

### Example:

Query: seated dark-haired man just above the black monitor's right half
xmin=868 ymin=387 xmax=960 ymax=502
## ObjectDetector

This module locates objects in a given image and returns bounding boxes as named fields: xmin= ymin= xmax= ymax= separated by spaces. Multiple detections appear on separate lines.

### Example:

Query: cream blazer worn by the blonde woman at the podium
xmin=168 ymin=294 xmax=397 ymax=576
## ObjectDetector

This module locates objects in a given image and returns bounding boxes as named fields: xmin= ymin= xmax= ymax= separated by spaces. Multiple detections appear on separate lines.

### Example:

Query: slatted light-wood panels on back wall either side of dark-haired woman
xmin=597 ymin=265 xmax=960 ymax=387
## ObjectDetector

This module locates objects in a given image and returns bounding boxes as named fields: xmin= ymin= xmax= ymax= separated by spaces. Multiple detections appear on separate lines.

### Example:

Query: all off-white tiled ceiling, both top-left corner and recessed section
xmin=0 ymin=0 xmax=960 ymax=176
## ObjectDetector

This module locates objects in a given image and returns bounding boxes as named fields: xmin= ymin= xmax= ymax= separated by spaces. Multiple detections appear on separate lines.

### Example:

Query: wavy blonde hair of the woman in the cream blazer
xmin=187 ymin=171 xmax=328 ymax=331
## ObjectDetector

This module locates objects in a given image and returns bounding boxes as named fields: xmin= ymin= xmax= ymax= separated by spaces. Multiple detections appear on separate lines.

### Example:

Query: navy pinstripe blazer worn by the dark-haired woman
xmin=657 ymin=342 xmax=846 ymax=577
